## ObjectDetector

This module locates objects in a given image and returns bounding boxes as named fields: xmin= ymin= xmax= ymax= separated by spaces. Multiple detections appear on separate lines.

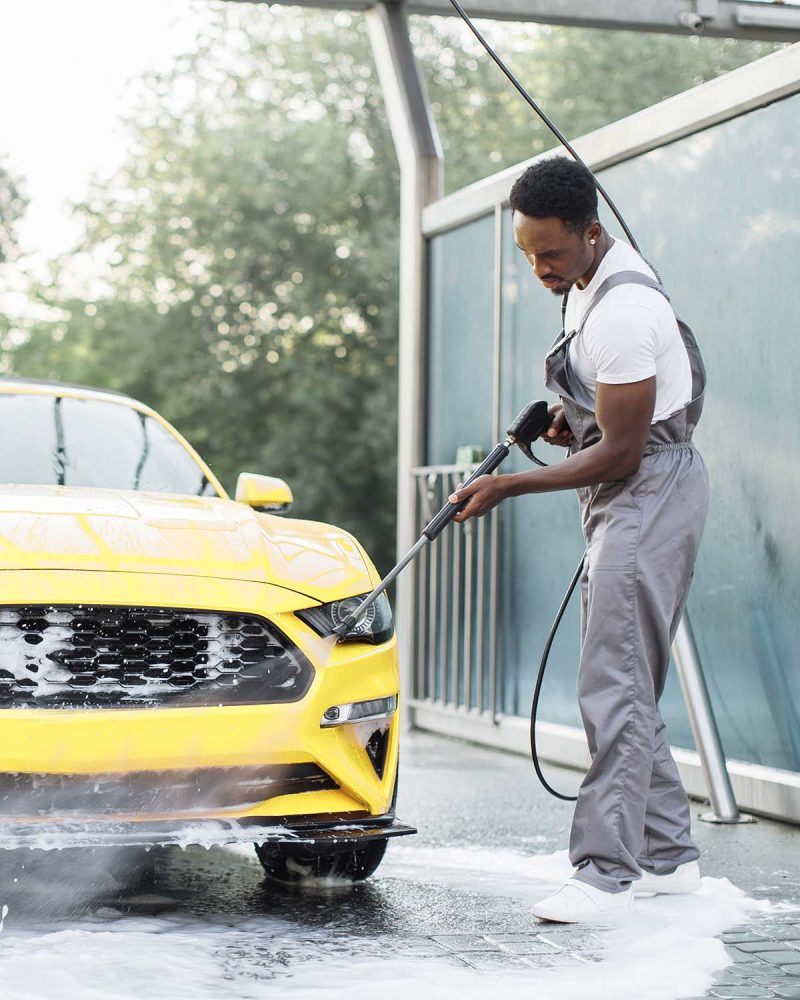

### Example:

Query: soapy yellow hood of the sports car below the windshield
xmin=0 ymin=486 xmax=373 ymax=601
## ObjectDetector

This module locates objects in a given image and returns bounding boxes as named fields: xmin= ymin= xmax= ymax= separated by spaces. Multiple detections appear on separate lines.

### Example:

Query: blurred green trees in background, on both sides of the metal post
xmin=0 ymin=4 xmax=770 ymax=569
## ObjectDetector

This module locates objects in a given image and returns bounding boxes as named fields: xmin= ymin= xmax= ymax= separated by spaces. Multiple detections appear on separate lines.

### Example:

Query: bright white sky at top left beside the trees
xmin=0 ymin=0 xmax=216 ymax=257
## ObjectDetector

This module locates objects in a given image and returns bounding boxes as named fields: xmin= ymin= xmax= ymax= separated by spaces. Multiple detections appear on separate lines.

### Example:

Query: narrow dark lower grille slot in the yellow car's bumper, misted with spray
xmin=0 ymin=764 xmax=338 ymax=819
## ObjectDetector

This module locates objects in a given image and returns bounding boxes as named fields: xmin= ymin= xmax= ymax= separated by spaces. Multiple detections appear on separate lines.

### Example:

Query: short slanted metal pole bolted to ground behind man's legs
xmin=672 ymin=613 xmax=752 ymax=823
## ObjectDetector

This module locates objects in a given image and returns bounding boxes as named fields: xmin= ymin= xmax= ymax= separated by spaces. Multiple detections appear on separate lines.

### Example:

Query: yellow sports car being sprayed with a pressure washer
xmin=0 ymin=379 xmax=415 ymax=881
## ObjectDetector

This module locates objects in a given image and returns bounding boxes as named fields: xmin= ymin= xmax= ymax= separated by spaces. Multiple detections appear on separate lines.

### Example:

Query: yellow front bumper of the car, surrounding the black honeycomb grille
xmin=0 ymin=573 xmax=399 ymax=846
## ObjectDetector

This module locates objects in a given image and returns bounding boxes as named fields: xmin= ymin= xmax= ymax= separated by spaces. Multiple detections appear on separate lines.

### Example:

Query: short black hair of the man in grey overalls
xmin=509 ymin=156 xmax=597 ymax=232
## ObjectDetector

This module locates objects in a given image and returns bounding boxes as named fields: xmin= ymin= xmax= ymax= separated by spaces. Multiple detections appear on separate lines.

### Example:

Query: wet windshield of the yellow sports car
xmin=0 ymin=393 xmax=217 ymax=496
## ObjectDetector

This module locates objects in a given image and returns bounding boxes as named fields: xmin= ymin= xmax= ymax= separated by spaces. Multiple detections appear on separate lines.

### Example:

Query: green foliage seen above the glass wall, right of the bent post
xmin=415 ymin=18 xmax=776 ymax=192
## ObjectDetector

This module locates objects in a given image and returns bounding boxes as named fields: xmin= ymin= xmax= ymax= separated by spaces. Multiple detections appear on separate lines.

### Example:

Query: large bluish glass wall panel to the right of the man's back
xmin=603 ymin=96 xmax=800 ymax=770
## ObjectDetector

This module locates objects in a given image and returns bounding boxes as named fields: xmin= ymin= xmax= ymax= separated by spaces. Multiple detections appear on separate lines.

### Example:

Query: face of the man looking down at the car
xmin=514 ymin=212 xmax=600 ymax=295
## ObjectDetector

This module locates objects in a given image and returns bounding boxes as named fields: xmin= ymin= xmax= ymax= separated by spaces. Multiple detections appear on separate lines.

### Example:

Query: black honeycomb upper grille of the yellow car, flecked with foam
xmin=0 ymin=605 xmax=314 ymax=708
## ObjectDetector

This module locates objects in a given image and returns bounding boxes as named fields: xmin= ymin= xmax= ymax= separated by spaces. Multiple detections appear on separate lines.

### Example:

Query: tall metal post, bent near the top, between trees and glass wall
xmin=365 ymin=3 xmax=443 ymax=727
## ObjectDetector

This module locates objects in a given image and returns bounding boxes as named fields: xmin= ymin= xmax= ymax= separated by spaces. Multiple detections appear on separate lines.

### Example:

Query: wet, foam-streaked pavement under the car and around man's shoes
xmin=0 ymin=734 xmax=800 ymax=1000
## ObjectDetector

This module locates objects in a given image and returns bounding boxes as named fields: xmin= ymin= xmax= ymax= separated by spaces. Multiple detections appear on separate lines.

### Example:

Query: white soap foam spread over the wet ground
xmin=0 ymin=845 xmax=769 ymax=1000
